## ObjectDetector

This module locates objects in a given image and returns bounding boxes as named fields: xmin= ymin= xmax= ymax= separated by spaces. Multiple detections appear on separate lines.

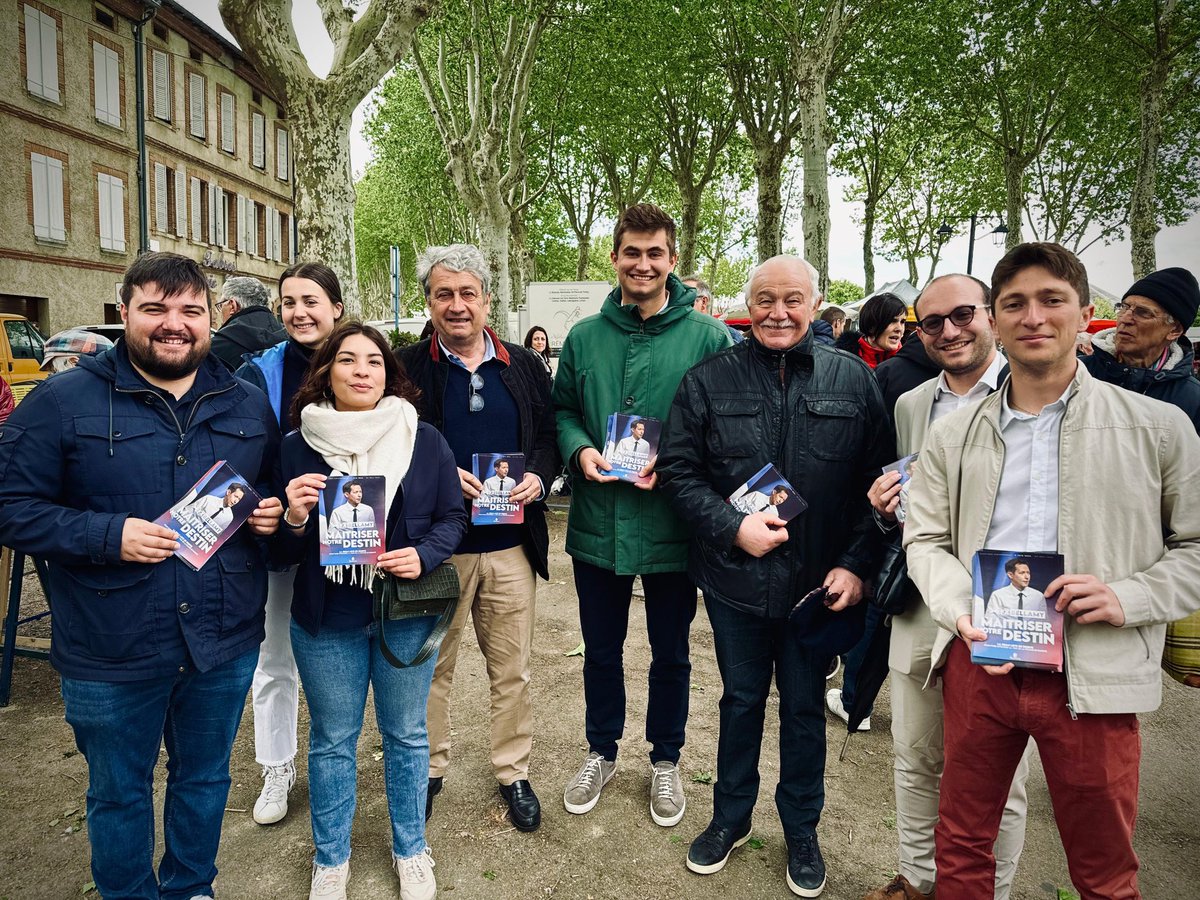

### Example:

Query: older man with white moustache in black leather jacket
xmin=658 ymin=256 xmax=893 ymax=896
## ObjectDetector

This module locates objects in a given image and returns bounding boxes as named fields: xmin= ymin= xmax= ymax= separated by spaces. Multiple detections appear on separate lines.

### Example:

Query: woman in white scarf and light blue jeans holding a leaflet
xmin=278 ymin=323 xmax=467 ymax=900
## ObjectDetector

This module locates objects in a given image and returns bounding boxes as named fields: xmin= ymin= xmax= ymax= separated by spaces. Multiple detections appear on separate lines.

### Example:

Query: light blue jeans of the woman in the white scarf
xmin=292 ymin=617 xmax=438 ymax=865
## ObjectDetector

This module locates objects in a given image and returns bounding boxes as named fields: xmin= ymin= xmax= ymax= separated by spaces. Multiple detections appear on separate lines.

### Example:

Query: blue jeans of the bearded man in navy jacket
xmin=62 ymin=649 xmax=258 ymax=900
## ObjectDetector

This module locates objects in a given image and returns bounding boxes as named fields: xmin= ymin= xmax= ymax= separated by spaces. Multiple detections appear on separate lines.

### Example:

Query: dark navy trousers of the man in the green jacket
xmin=574 ymin=559 xmax=696 ymax=764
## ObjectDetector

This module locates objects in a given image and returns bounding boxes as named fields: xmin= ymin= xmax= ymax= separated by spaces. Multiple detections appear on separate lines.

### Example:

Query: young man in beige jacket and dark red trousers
xmin=904 ymin=244 xmax=1200 ymax=900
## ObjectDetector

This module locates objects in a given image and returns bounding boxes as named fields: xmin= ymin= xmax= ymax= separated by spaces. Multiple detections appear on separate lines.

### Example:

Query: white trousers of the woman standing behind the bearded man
xmin=251 ymin=566 xmax=300 ymax=766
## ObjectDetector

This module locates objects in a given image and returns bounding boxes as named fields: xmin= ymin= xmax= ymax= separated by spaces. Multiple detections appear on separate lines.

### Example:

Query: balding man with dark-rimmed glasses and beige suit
xmin=863 ymin=275 xmax=1028 ymax=900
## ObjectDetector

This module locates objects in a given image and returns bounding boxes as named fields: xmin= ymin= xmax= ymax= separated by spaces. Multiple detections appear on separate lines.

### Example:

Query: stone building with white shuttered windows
xmin=0 ymin=0 xmax=294 ymax=335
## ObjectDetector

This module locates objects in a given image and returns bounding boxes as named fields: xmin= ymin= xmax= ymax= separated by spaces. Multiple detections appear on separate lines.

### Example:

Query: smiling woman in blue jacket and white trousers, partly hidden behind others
xmin=238 ymin=263 xmax=346 ymax=824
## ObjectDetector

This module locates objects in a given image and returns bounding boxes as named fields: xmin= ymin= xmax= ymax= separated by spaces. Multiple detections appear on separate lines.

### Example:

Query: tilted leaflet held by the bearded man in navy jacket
xmin=155 ymin=460 xmax=263 ymax=571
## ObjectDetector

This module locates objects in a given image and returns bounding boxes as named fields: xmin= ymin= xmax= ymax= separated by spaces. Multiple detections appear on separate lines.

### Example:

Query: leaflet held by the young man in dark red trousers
xmin=971 ymin=550 xmax=1063 ymax=672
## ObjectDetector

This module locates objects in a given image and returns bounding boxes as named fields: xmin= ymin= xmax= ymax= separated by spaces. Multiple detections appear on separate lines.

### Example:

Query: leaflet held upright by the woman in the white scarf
xmin=317 ymin=475 xmax=388 ymax=565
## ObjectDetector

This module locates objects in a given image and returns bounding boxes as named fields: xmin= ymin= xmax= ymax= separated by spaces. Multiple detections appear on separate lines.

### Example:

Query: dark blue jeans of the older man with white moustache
xmin=706 ymin=600 xmax=829 ymax=836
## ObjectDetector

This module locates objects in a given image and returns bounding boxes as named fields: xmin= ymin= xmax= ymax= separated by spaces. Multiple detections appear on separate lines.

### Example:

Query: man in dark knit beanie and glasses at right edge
xmin=1082 ymin=268 xmax=1200 ymax=432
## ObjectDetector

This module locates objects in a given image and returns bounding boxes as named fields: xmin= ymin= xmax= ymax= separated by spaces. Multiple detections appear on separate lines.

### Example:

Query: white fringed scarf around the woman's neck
xmin=300 ymin=396 xmax=418 ymax=590
